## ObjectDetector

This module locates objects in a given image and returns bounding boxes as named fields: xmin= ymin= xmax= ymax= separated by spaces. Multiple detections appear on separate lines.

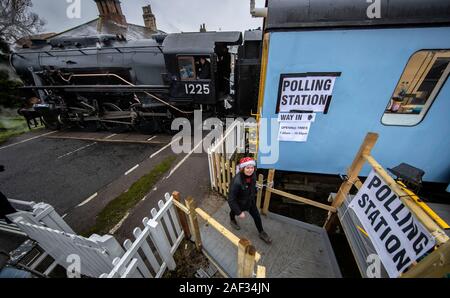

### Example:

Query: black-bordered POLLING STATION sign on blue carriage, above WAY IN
xmin=277 ymin=73 xmax=340 ymax=114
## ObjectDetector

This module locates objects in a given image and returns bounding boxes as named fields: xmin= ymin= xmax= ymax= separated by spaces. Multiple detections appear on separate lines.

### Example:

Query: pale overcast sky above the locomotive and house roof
xmin=32 ymin=0 xmax=265 ymax=33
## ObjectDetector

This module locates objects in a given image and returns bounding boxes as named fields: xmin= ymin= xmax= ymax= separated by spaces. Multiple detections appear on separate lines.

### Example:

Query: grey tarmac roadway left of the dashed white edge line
xmin=0 ymin=131 xmax=168 ymax=215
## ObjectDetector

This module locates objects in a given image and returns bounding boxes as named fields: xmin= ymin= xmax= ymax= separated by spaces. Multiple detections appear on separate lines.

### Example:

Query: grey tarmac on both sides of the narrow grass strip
xmin=0 ymin=127 xmax=218 ymax=248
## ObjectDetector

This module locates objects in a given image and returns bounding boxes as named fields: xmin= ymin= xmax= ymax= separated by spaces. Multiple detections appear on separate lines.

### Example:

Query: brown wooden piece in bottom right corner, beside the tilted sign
xmin=401 ymin=241 xmax=450 ymax=278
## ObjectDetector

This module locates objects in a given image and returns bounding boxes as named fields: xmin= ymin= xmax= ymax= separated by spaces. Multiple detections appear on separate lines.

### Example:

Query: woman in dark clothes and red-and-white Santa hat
xmin=228 ymin=157 xmax=272 ymax=244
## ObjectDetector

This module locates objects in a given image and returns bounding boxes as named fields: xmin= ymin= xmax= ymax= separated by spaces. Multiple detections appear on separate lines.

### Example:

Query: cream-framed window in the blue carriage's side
xmin=381 ymin=50 xmax=450 ymax=126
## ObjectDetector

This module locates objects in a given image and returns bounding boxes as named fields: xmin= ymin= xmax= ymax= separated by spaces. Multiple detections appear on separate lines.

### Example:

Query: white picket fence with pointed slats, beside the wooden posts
xmin=100 ymin=194 xmax=184 ymax=278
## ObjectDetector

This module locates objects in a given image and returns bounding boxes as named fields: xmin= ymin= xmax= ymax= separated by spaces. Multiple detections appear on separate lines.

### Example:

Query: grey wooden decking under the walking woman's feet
xmin=200 ymin=202 xmax=341 ymax=278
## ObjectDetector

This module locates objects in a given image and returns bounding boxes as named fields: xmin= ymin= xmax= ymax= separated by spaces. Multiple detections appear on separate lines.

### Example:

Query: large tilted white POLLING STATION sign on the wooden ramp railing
xmin=349 ymin=171 xmax=435 ymax=277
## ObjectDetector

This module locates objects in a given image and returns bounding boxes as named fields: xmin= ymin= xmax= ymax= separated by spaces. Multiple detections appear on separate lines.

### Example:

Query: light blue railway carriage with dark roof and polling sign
xmin=258 ymin=0 xmax=450 ymax=185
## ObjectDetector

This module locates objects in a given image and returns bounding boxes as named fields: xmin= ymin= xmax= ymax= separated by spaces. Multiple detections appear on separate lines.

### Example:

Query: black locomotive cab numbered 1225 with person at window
xmin=163 ymin=32 xmax=242 ymax=107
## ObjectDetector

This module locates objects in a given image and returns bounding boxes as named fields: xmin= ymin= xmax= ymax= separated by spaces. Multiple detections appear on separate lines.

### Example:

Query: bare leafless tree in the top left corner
xmin=0 ymin=0 xmax=45 ymax=42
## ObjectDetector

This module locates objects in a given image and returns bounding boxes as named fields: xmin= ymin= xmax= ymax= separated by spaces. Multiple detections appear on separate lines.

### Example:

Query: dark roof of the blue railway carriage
xmin=266 ymin=0 xmax=450 ymax=30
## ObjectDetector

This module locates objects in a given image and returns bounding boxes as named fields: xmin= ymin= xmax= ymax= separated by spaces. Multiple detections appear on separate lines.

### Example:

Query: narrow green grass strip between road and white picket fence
xmin=82 ymin=156 xmax=176 ymax=237
